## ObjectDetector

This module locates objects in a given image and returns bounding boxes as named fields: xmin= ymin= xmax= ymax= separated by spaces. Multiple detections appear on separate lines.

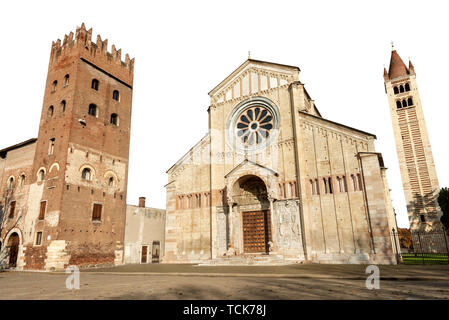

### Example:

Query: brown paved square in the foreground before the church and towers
xmin=0 ymin=264 xmax=449 ymax=300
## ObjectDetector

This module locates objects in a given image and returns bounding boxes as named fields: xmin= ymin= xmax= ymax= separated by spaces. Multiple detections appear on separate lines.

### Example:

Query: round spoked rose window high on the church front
xmin=236 ymin=106 xmax=274 ymax=146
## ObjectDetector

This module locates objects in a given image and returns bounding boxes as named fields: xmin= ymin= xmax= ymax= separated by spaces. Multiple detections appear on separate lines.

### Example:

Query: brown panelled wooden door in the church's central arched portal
xmin=242 ymin=210 xmax=271 ymax=253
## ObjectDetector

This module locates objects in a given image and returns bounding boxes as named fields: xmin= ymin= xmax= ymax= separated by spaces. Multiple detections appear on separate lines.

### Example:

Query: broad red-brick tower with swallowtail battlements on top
xmin=30 ymin=24 xmax=134 ymax=270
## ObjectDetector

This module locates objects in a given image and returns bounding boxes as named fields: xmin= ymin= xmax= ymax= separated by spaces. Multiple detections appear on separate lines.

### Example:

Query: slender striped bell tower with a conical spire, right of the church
xmin=384 ymin=47 xmax=442 ymax=231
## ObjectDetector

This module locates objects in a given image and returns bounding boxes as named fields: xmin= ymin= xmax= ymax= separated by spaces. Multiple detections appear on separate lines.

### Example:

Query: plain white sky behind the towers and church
xmin=0 ymin=0 xmax=449 ymax=227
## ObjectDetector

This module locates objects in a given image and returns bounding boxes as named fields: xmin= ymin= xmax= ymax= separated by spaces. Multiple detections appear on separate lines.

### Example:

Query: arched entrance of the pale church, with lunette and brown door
xmin=232 ymin=176 xmax=271 ymax=253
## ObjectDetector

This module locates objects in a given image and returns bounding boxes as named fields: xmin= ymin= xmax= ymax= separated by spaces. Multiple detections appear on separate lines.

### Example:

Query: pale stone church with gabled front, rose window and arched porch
xmin=163 ymin=59 xmax=396 ymax=264
